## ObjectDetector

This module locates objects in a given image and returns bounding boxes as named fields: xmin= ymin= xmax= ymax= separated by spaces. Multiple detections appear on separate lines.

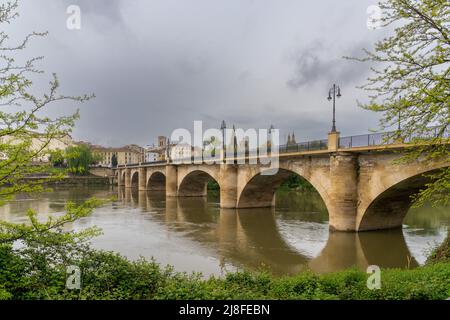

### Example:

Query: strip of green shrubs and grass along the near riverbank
xmin=0 ymin=246 xmax=450 ymax=300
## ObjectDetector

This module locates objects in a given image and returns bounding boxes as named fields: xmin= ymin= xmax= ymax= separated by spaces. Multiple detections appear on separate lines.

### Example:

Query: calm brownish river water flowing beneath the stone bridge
xmin=0 ymin=187 xmax=450 ymax=275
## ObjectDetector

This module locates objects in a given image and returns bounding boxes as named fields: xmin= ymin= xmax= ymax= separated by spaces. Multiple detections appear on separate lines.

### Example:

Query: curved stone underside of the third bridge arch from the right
xmin=178 ymin=169 xmax=220 ymax=197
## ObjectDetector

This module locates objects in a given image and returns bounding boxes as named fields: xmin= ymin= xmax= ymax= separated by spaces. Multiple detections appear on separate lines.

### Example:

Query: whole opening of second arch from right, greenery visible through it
xmin=238 ymin=169 xmax=327 ymax=214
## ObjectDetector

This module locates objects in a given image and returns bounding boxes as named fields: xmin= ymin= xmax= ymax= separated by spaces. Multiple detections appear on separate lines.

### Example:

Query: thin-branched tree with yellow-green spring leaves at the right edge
xmin=351 ymin=0 xmax=450 ymax=205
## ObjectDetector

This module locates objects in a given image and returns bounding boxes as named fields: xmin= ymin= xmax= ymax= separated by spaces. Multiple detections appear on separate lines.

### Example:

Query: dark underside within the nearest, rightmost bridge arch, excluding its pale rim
xmin=357 ymin=170 xmax=446 ymax=231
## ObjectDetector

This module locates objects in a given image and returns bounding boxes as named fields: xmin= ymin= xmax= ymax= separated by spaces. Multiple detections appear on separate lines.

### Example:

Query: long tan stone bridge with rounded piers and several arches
xmin=116 ymin=132 xmax=449 ymax=231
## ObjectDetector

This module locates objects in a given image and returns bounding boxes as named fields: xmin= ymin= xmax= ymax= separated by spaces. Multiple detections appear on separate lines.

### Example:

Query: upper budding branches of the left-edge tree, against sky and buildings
xmin=0 ymin=1 xmax=90 ymax=205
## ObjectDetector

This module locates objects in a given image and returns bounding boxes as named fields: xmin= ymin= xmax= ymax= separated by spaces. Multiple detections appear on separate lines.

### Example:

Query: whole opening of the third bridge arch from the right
xmin=178 ymin=170 xmax=220 ymax=197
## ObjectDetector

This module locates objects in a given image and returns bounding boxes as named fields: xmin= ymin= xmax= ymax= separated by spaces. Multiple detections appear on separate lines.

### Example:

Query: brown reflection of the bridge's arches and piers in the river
xmin=118 ymin=188 xmax=418 ymax=274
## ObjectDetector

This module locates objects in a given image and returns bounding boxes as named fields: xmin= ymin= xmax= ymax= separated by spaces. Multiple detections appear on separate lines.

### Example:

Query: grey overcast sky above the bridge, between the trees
xmin=5 ymin=0 xmax=386 ymax=146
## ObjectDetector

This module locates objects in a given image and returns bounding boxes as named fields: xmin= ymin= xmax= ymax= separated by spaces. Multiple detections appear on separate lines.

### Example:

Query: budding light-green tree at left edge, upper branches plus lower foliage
xmin=0 ymin=1 xmax=100 ymax=297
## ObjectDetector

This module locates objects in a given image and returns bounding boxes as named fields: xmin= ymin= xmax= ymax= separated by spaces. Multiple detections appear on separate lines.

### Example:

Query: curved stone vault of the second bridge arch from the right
xmin=237 ymin=166 xmax=329 ymax=209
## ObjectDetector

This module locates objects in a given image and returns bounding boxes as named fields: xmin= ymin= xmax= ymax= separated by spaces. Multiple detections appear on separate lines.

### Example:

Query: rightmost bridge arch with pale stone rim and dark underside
xmin=356 ymin=163 xmax=449 ymax=231
